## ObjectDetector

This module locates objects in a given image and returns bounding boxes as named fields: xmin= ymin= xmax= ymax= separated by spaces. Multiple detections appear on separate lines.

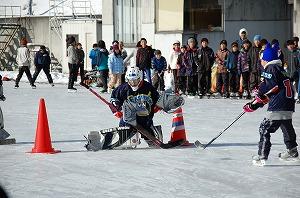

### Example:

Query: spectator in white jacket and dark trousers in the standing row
xmin=168 ymin=41 xmax=181 ymax=93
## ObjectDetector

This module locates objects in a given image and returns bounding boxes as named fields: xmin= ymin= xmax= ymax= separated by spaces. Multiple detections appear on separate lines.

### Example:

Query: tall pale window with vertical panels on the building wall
xmin=114 ymin=0 xmax=140 ymax=44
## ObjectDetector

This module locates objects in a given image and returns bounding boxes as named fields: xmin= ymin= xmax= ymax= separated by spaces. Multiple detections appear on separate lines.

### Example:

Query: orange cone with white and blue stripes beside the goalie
xmin=170 ymin=107 xmax=192 ymax=146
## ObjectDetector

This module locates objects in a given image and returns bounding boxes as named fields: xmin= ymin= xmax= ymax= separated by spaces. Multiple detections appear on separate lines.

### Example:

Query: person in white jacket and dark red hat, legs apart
xmin=15 ymin=38 xmax=36 ymax=89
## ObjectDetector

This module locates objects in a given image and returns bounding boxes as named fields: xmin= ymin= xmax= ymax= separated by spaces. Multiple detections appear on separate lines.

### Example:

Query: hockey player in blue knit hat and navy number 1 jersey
xmin=244 ymin=44 xmax=298 ymax=166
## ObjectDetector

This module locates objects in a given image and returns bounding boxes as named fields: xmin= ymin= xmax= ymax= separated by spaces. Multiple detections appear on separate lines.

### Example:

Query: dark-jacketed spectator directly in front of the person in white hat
xmin=238 ymin=39 xmax=251 ymax=99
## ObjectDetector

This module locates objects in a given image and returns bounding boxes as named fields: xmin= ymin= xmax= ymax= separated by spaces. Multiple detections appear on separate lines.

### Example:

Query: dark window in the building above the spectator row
xmin=184 ymin=0 xmax=224 ymax=32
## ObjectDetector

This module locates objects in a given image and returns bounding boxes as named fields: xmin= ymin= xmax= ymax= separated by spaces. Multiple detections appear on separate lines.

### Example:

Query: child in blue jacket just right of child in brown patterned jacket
xmin=226 ymin=42 xmax=240 ymax=98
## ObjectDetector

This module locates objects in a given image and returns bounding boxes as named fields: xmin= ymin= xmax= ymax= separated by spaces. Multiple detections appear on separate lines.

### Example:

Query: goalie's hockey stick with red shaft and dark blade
xmin=81 ymin=83 xmax=184 ymax=149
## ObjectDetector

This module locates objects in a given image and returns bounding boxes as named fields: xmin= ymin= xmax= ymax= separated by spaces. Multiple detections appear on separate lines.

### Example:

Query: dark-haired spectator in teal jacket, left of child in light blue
xmin=97 ymin=40 xmax=109 ymax=93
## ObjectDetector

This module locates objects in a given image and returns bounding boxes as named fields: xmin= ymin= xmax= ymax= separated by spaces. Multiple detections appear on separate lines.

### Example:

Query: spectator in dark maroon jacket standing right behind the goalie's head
xmin=136 ymin=38 xmax=154 ymax=84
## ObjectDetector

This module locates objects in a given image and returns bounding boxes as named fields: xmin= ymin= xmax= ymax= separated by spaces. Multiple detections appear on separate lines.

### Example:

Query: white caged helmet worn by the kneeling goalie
xmin=125 ymin=67 xmax=143 ymax=91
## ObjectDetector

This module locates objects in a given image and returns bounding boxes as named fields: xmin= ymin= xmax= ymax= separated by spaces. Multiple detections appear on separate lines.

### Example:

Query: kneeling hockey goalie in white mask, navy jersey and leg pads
xmin=86 ymin=67 xmax=184 ymax=150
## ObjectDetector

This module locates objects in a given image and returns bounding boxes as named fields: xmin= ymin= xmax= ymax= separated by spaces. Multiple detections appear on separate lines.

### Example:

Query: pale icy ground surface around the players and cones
xmin=0 ymin=77 xmax=300 ymax=198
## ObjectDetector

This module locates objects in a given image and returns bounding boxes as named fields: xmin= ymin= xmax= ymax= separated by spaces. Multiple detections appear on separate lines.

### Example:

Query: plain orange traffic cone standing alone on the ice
xmin=31 ymin=98 xmax=60 ymax=154
